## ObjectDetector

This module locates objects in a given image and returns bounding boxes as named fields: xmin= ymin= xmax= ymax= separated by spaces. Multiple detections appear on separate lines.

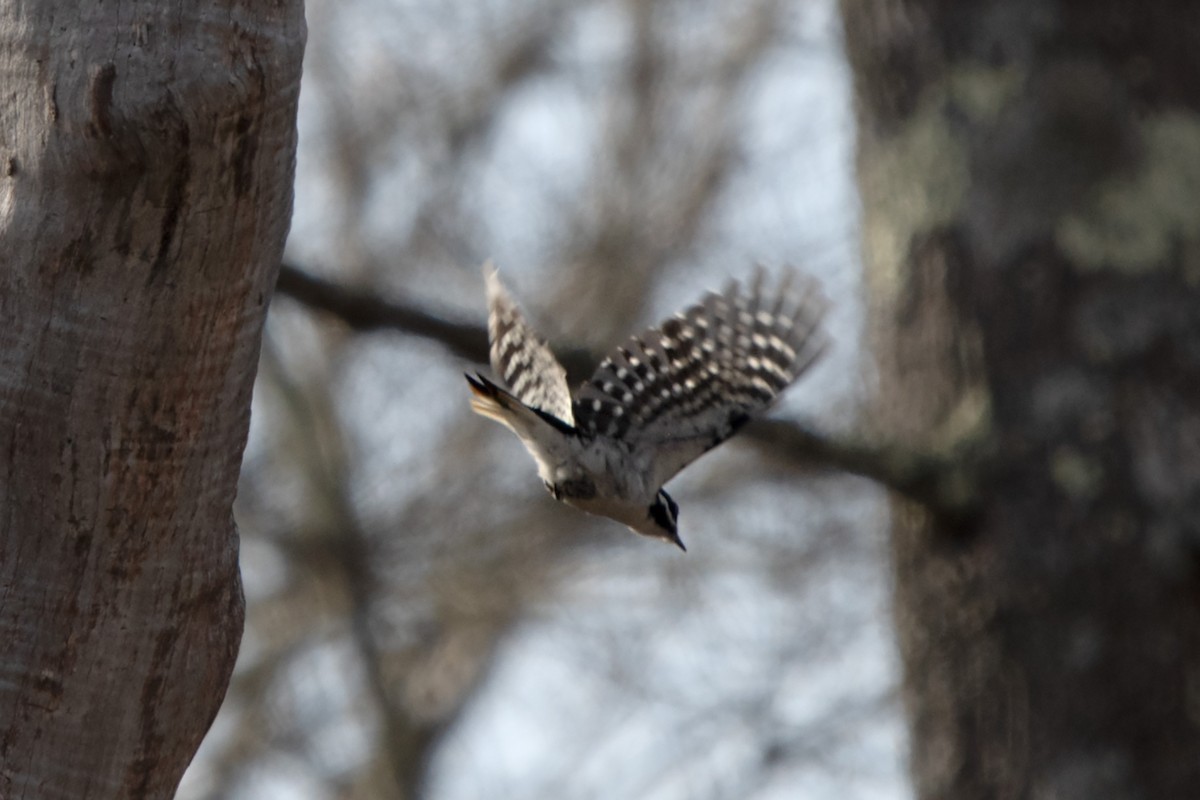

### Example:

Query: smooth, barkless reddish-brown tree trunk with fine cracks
xmin=0 ymin=0 xmax=304 ymax=799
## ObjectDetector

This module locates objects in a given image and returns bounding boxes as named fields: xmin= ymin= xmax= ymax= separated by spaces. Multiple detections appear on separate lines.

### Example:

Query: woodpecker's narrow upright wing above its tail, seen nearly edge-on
xmin=484 ymin=261 xmax=575 ymax=426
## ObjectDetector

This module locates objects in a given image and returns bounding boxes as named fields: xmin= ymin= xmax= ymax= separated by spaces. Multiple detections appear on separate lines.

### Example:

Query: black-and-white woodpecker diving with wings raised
xmin=467 ymin=263 xmax=826 ymax=551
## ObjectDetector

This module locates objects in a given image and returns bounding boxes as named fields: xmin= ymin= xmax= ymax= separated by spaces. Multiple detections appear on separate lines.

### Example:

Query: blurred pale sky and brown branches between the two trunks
xmin=179 ymin=0 xmax=910 ymax=800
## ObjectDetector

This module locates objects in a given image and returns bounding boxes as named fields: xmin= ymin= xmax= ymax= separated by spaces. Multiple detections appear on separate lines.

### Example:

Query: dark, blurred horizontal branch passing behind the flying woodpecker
xmin=277 ymin=264 xmax=980 ymax=521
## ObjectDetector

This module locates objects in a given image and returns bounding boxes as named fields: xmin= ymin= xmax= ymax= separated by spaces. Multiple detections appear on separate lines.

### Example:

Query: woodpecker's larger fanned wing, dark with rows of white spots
xmin=575 ymin=270 xmax=826 ymax=486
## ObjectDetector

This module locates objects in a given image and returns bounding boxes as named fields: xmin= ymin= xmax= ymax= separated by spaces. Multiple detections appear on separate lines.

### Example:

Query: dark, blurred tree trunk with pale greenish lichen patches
xmin=842 ymin=0 xmax=1200 ymax=800
